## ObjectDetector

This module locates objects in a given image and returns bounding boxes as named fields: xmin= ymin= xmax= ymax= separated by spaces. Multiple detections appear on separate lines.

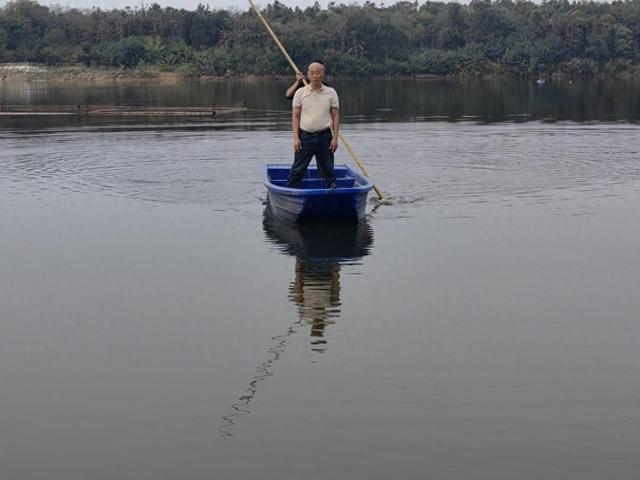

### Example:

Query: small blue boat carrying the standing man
xmin=264 ymin=164 xmax=373 ymax=222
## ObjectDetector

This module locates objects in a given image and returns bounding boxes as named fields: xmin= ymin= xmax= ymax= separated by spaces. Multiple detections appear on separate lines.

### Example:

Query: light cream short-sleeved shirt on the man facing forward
xmin=293 ymin=85 xmax=340 ymax=132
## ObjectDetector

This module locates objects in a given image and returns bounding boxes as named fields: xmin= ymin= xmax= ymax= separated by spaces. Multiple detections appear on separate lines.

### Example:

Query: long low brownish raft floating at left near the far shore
xmin=0 ymin=105 xmax=247 ymax=117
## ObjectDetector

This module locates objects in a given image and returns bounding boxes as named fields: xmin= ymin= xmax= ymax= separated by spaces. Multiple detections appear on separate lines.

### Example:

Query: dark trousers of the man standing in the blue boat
xmin=287 ymin=128 xmax=336 ymax=188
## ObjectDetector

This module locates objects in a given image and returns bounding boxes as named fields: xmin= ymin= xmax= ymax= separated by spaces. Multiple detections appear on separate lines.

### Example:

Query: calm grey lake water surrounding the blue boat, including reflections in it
xmin=0 ymin=81 xmax=640 ymax=480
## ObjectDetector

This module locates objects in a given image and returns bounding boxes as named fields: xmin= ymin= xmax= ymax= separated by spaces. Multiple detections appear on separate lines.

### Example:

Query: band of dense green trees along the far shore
xmin=0 ymin=0 xmax=640 ymax=75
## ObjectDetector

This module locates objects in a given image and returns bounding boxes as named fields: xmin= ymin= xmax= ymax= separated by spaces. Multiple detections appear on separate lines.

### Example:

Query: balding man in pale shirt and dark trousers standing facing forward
xmin=287 ymin=62 xmax=340 ymax=189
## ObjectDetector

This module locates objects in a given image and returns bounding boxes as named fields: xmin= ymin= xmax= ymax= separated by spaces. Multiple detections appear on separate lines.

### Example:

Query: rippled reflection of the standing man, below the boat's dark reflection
xmin=289 ymin=257 xmax=340 ymax=352
